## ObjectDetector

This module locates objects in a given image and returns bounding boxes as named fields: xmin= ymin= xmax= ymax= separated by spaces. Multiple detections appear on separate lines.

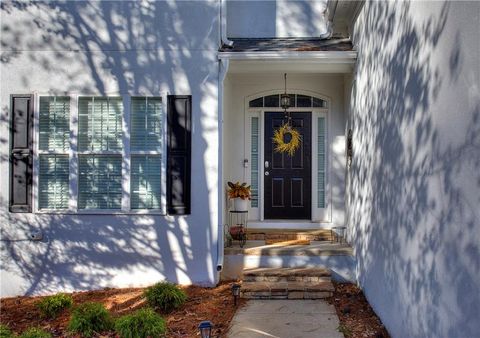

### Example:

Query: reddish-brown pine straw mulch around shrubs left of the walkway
xmin=0 ymin=282 xmax=244 ymax=338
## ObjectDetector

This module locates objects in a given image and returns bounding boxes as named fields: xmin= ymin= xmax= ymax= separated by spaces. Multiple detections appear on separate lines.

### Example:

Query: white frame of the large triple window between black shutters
xmin=32 ymin=92 xmax=168 ymax=216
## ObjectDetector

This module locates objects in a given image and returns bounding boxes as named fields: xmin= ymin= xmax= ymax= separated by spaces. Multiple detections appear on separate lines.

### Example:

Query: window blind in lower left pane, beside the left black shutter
xmin=38 ymin=154 xmax=69 ymax=209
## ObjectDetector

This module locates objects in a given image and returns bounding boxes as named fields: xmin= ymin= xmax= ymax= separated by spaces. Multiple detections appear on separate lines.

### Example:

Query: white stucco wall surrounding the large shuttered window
xmin=0 ymin=1 xmax=219 ymax=296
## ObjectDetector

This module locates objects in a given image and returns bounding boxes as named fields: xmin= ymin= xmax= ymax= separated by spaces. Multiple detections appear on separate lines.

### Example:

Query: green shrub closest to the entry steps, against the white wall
xmin=145 ymin=282 xmax=187 ymax=312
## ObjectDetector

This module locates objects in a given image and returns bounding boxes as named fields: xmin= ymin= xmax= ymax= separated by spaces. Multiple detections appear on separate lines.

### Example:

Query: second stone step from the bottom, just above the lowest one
xmin=243 ymin=268 xmax=331 ymax=282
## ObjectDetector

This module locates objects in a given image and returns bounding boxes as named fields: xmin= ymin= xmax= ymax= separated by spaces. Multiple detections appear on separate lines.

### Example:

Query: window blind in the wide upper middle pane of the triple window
xmin=78 ymin=97 xmax=123 ymax=151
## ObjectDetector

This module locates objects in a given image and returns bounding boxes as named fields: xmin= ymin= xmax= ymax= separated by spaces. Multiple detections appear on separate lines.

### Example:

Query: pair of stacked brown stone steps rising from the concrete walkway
xmin=241 ymin=268 xmax=334 ymax=299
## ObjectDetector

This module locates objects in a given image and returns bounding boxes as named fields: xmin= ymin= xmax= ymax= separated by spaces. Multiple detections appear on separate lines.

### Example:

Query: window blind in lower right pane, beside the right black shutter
xmin=130 ymin=155 xmax=162 ymax=209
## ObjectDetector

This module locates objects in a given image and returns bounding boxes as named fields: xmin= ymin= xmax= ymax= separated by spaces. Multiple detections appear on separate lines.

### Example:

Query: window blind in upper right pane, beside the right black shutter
xmin=130 ymin=97 xmax=162 ymax=151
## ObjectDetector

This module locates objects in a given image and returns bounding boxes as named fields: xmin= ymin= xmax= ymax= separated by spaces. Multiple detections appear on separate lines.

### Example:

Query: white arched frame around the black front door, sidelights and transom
xmin=244 ymin=89 xmax=332 ymax=223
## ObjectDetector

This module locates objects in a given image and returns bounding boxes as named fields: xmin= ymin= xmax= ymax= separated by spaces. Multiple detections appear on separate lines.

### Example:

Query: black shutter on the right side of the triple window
xmin=167 ymin=95 xmax=192 ymax=215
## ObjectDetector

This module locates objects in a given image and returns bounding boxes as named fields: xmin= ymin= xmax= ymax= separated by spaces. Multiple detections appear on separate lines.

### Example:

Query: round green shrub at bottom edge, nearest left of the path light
xmin=115 ymin=308 xmax=167 ymax=338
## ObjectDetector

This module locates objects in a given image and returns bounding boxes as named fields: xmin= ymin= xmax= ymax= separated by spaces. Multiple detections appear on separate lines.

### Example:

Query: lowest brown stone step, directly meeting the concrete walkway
xmin=240 ymin=280 xmax=334 ymax=299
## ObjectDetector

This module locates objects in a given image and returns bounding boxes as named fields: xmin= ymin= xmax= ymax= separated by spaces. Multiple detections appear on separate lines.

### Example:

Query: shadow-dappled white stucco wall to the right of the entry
xmin=348 ymin=1 xmax=480 ymax=337
